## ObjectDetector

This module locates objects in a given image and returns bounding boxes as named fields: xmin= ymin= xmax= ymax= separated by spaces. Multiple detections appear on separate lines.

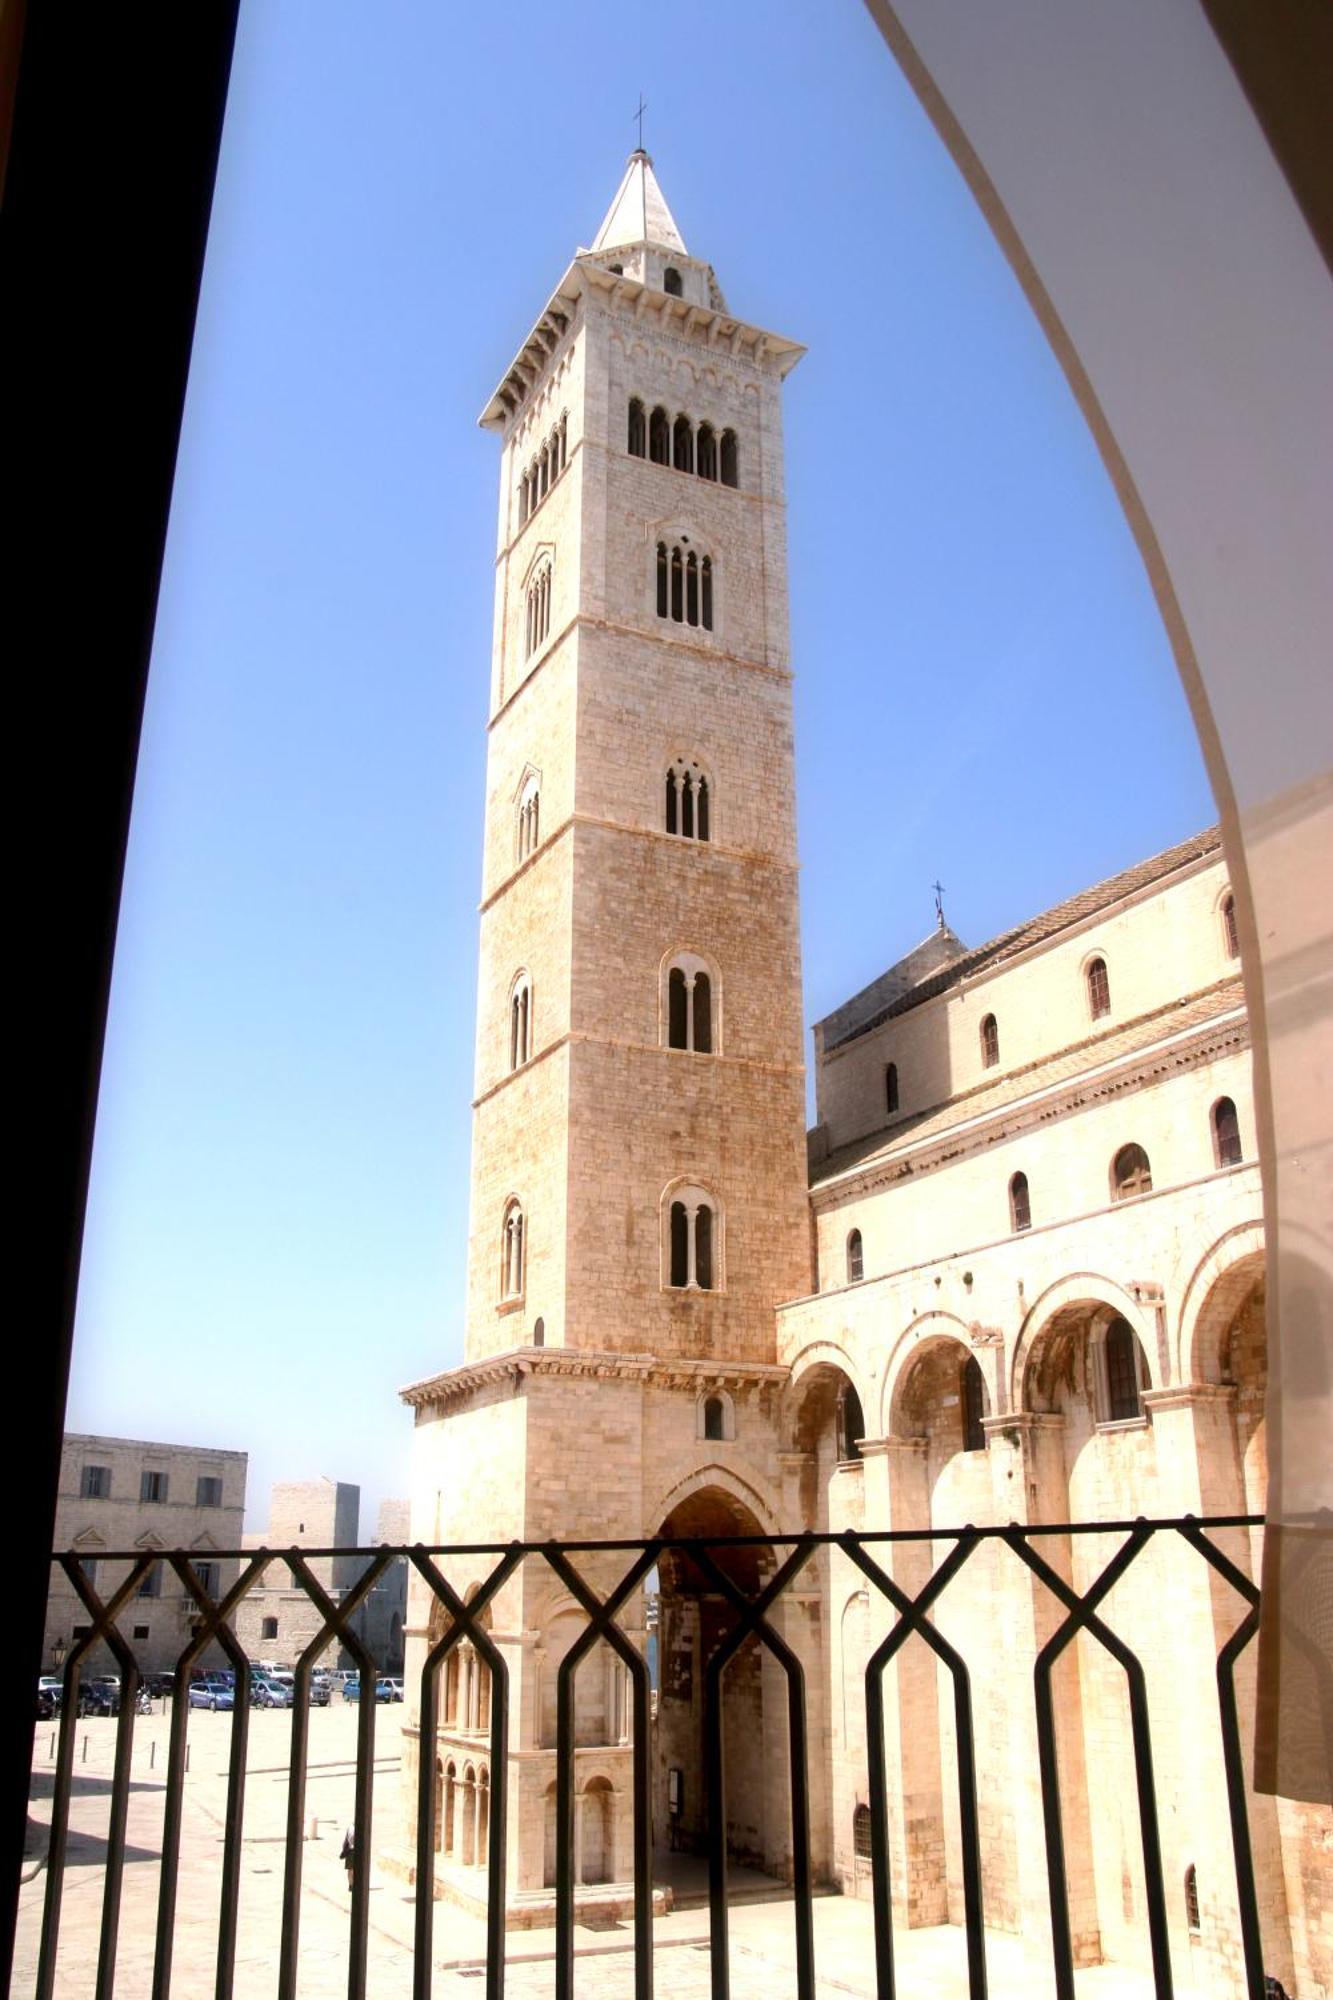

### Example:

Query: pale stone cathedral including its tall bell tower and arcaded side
xmin=404 ymin=152 xmax=1333 ymax=1994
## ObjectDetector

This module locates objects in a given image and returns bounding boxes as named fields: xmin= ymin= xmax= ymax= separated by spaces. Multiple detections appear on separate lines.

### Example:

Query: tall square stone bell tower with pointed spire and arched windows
xmin=394 ymin=152 xmax=811 ymax=1898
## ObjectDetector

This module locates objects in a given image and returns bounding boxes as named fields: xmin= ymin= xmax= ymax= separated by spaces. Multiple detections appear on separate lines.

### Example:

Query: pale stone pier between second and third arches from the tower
xmin=973 ymin=1412 xmax=1101 ymax=1966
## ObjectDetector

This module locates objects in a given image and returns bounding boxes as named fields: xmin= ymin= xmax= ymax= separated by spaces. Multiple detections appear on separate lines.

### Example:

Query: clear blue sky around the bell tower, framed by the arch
xmin=70 ymin=0 xmax=1213 ymax=1528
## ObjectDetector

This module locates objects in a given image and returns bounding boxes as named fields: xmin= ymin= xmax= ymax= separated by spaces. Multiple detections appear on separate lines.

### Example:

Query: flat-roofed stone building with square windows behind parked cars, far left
xmin=42 ymin=1432 xmax=246 ymax=1674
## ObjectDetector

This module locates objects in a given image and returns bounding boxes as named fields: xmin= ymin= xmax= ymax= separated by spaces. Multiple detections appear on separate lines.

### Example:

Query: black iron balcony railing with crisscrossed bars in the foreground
xmin=14 ymin=1514 xmax=1288 ymax=2000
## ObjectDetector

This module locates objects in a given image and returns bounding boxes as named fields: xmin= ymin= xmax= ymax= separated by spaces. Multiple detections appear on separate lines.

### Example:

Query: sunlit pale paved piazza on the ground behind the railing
xmin=12 ymin=1702 xmax=1151 ymax=2000
